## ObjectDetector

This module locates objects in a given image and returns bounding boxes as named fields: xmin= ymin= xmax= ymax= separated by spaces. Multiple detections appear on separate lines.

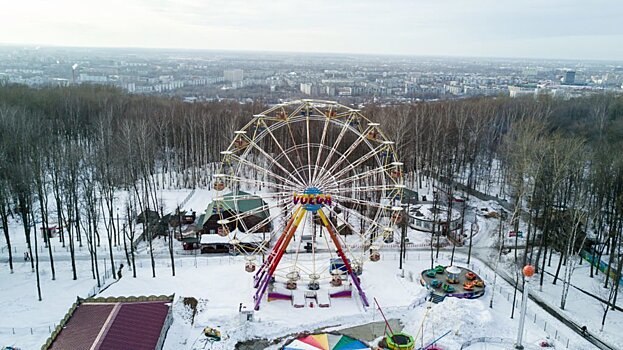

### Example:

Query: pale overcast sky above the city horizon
xmin=0 ymin=0 xmax=623 ymax=60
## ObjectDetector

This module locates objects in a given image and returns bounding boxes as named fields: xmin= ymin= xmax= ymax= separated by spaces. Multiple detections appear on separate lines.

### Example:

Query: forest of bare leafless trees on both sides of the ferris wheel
xmin=0 ymin=86 xmax=623 ymax=326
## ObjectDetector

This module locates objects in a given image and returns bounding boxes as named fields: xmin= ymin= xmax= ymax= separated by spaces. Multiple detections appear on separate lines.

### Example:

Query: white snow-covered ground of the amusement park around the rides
xmin=0 ymin=180 xmax=623 ymax=349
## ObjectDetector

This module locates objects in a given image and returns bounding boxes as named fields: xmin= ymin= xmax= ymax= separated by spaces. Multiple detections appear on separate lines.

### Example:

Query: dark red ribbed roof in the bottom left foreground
xmin=41 ymin=296 xmax=173 ymax=350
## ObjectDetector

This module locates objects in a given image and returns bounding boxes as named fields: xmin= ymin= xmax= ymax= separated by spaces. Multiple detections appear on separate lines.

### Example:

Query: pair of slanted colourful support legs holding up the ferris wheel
xmin=253 ymin=207 xmax=370 ymax=311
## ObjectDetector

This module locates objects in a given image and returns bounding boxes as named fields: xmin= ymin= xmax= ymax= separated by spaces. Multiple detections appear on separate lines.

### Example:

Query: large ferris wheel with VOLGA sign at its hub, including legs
xmin=213 ymin=100 xmax=404 ymax=309
